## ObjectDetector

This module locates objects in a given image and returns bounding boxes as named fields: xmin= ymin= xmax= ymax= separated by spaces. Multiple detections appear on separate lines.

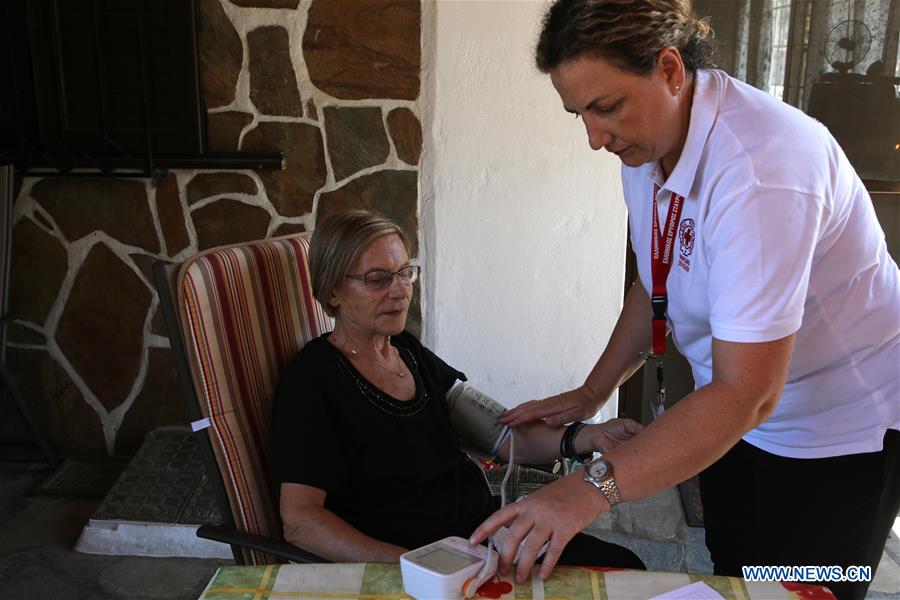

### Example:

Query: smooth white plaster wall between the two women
xmin=420 ymin=0 xmax=626 ymax=417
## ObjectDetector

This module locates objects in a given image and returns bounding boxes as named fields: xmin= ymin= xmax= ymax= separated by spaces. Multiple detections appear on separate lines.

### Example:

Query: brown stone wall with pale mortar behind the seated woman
xmin=7 ymin=0 xmax=422 ymax=456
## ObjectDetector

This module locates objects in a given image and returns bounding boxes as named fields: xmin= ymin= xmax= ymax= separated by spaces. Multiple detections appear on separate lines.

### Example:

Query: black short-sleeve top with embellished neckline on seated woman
xmin=272 ymin=332 xmax=494 ymax=549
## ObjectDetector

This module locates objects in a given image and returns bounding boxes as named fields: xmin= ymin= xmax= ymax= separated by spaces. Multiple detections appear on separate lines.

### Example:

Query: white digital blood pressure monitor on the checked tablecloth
xmin=400 ymin=537 xmax=497 ymax=600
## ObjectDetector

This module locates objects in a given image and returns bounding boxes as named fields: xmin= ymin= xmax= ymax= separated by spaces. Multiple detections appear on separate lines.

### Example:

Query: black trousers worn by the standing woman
xmin=700 ymin=430 xmax=900 ymax=600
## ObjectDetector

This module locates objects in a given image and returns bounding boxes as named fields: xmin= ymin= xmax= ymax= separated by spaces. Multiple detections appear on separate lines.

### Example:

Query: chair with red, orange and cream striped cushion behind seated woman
xmin=157 ymin=233 xmax=333 ymax=564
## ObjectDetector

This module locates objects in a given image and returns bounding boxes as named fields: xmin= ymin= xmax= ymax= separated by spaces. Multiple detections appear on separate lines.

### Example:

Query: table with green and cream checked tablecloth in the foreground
xmin=200 ymin=563 xmax=834 ymax=600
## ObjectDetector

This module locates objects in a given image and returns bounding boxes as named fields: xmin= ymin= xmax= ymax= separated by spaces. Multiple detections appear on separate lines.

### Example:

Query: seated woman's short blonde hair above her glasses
xmin=309 ymin=210 xmax=409 ymax=317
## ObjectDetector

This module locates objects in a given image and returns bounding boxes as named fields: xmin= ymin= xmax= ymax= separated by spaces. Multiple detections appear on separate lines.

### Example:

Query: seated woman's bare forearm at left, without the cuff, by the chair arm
xmin=284 ymin=507 xmax=407 ymax=563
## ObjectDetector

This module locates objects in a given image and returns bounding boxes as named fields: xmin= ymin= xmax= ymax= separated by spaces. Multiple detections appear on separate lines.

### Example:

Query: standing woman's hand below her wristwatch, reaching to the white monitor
xmin=469 ymin=471 xmax=608 ymax=583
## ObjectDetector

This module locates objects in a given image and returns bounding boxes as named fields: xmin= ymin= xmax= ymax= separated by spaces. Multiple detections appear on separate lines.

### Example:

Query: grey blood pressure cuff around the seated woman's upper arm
xmin=447 ymin=381 xmax=509 ymax=458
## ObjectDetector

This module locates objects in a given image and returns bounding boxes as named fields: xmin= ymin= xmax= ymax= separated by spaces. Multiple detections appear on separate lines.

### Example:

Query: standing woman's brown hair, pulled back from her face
xmin=535 ymin=0 xmax=715 ymax=75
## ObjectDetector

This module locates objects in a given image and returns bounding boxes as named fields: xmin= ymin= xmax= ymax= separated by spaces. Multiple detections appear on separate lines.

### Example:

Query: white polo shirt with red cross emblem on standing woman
xmin=622 ymin=70 xmax=900 ymax=458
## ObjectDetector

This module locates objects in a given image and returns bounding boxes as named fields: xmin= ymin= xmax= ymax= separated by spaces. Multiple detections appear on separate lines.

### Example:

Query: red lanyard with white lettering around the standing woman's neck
xmin=650 ymin=183 xmax=684 ymax=355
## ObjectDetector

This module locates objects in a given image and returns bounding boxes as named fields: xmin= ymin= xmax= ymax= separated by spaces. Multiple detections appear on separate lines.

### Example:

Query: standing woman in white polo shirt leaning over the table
xmin=472 ymin=0 xmax=900 ymax=598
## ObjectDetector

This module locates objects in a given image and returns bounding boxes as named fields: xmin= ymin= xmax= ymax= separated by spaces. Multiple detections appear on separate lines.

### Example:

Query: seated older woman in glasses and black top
xmin=272 ymin=211 xmax=643 ymax=568
